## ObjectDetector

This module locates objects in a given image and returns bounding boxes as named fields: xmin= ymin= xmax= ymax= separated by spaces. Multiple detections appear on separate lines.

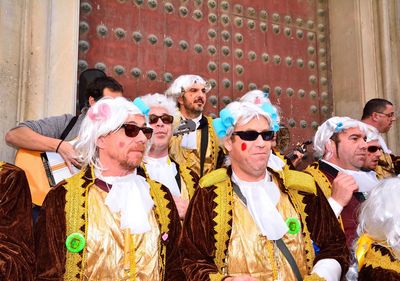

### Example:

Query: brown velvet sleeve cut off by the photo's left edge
xmin=0 ymin=162 xmax=35 ymax=281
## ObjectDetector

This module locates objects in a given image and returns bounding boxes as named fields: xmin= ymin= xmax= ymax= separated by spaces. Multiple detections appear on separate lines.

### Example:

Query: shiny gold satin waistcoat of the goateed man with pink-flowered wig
xmin=84 ymin=185 xmax=160 ymax=281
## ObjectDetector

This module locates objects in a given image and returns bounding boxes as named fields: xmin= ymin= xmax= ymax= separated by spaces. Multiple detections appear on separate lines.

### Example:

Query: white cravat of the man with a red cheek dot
xmin=232 ymin=172 xmax=288 ymax=240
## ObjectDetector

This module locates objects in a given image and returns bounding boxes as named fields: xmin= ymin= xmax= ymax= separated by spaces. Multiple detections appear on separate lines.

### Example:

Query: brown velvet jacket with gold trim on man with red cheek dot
xmin=180 ymin=168 xmax=349 ymax=281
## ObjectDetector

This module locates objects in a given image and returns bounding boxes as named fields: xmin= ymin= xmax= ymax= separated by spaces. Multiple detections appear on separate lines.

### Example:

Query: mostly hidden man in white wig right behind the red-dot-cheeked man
xmin=239 ymin=90 xmax=303 ymax=170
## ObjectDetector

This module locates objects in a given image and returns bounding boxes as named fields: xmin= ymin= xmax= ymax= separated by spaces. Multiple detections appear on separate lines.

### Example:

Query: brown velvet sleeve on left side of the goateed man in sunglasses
xmin=35 ymin=185 xmax=66 ymax=281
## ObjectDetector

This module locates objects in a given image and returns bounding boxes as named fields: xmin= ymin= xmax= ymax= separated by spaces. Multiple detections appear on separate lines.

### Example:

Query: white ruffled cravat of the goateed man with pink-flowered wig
xmin=96 ymin=170 xmax=154 ymax=234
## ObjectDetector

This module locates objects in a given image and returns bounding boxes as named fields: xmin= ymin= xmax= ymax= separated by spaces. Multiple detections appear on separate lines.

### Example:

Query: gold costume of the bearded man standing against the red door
xmin=169 ymin=117 xmax=219 ymax=175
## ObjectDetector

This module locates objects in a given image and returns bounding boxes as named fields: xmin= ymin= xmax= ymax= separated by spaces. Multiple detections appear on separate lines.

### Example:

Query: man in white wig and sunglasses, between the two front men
xmin=135 ymin=94 xmax=198 ymax=219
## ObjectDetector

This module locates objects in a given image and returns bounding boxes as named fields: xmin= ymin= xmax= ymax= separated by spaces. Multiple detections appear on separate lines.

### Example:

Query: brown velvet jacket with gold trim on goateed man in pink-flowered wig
xmin=35 ymin=165 xmax=186 ymax=281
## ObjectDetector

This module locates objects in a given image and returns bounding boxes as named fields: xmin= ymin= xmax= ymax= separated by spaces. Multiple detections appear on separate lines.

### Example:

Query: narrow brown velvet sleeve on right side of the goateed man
xmin=161 ymin=186 xmax=186 ymax=281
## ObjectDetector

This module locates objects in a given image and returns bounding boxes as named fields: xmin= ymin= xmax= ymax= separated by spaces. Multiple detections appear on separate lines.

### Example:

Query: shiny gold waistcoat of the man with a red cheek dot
xmin=228 ymin=189 xmax=307 ymax=281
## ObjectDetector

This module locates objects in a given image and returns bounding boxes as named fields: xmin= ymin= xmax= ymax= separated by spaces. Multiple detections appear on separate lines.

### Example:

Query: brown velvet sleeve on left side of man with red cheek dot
xmin=180 ymin=188 xmax=227 ymax=281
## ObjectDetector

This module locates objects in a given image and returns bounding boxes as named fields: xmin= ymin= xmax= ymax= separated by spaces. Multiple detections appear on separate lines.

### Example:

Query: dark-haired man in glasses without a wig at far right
xmin=361 ymin=99 xmax=400 ymax=178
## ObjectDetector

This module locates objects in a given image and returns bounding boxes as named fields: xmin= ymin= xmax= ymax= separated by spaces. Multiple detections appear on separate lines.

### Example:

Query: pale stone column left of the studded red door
xmin=0 ymin=0 xmax=80 ymax=162
